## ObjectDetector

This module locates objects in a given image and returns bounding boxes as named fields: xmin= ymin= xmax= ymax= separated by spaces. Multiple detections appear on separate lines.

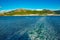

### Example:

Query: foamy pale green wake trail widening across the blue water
xmin=29 ymin=17 xmax=58 ymax=40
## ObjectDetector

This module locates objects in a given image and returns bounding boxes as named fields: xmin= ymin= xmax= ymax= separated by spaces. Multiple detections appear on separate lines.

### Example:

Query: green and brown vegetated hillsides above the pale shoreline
xmin=0 ymin=9 xmax=60 ymax=16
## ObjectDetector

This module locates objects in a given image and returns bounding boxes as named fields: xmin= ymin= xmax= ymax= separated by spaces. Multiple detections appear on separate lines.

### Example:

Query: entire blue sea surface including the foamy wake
xmin=0 ymin=16 xmax=60 ymax=40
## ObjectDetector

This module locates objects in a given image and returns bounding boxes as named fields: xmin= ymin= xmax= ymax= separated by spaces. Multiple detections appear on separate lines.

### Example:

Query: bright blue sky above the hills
xmin=0 ymin=0 xmax=60 ymax=10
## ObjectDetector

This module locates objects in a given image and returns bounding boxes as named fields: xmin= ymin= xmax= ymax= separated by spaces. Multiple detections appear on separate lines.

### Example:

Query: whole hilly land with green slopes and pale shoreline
xmin=0 ymin=9 xmax=60 ymax=16
